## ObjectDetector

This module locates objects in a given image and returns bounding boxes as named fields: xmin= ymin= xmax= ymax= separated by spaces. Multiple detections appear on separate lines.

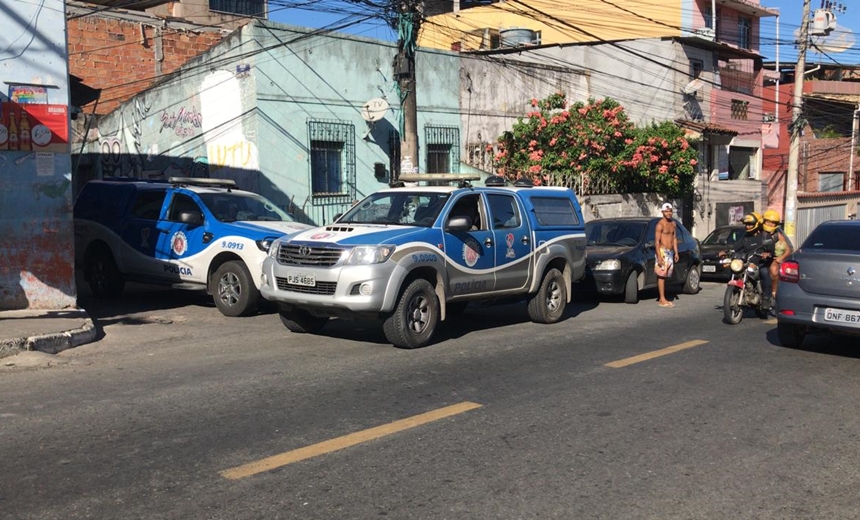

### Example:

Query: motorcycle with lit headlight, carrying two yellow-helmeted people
xmin=723 ymin=245 xmax=770 ymax=325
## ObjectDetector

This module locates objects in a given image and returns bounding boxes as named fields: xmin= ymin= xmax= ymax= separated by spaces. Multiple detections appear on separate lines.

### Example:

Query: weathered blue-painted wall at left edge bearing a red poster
xmin=0 ymin=0 xmax=76 ymax=310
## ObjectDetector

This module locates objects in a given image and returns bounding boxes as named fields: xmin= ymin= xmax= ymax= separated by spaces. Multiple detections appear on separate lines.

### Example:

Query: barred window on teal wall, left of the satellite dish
xmin=308 ymin=121 xmax=355 ymax=197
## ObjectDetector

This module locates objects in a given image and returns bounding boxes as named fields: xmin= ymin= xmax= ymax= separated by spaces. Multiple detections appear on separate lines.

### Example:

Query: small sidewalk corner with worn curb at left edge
xmin=0 ymin=309 xmax=97 ymax=363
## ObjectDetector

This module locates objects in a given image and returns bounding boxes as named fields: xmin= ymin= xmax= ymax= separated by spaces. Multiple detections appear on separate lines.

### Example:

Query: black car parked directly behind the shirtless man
xmin=584 ymin=217 xmax=702 ymax=303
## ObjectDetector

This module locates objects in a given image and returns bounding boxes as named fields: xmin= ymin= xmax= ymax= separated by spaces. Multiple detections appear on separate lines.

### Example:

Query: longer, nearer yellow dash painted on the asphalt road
xmin=220 ymin=401 xmax=481 ymax=480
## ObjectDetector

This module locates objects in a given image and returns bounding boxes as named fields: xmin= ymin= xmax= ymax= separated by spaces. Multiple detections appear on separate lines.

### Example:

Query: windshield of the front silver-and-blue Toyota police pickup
xmin=338 ymin=191 xmax=450 ymax=227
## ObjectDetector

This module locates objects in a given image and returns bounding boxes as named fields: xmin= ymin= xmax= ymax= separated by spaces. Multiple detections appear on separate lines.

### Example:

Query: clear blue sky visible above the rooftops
xmin=270 ymin=0 xmax=860 ymax=65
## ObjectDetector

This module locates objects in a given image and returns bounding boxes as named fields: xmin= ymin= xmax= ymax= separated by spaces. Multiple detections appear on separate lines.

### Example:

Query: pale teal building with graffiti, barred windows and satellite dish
xmin=82 ymin=21 xmax=462 ymax=224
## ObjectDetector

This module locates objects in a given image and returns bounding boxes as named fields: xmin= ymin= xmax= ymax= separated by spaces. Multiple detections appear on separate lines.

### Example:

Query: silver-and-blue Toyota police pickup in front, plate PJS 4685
xmin=260 ymin=174 xmax=585 ymax=348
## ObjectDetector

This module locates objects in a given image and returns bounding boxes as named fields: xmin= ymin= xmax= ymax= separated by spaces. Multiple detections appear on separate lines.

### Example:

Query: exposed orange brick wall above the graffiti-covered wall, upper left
xmin=68 ymin=15 xmax=224 ymax=114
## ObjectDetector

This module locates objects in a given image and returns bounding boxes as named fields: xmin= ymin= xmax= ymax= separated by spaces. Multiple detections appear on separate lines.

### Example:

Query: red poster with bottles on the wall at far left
xmin=0 ymin=102 xmax=69 ymax=153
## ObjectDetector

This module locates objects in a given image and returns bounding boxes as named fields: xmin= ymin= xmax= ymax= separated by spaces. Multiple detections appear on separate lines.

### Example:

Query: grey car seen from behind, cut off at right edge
xmin=776 ymin=220 xmax=860 ymax=348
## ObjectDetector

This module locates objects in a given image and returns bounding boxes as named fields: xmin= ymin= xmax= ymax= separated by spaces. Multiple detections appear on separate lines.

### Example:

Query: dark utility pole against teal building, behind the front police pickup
xmin=392 ymin=0 xmax=424 ymax=182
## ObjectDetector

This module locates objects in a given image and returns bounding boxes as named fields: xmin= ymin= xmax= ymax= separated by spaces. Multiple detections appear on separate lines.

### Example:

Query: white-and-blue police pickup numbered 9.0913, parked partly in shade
xmin=74 ymin=177 xmax=311 ymax=316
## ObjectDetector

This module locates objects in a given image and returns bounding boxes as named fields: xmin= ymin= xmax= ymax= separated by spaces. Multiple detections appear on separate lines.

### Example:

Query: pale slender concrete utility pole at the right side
xmin=784 ymin=0 xmax=810 ymax=247
